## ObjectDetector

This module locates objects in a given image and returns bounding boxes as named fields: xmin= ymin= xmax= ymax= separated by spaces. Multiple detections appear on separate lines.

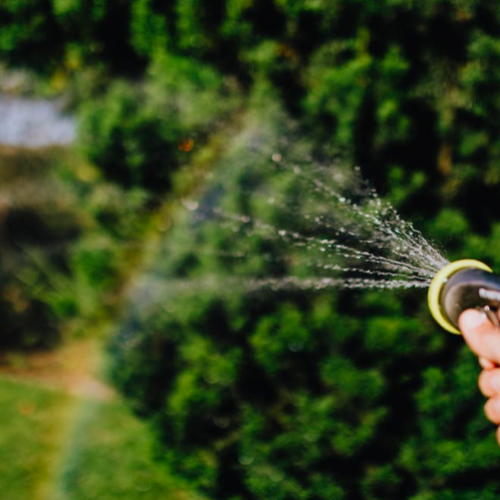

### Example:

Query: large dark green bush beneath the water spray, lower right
xmin=111 ymin=97 xmax=499 ymax=500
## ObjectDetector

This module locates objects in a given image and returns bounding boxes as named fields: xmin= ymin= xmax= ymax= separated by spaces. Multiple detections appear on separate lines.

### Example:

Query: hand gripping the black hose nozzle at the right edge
xmin=459 ymin=309 xmax=500 ymax=444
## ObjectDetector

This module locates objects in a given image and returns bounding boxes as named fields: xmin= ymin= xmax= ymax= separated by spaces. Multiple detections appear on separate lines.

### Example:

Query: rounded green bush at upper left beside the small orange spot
xmin=80 ymin=55 xmax=238 ymax=194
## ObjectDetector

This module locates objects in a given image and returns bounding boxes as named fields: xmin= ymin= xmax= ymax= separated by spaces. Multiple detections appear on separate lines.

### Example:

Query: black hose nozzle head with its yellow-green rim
xmin=428 ymin=259 xmax=500 ymax=334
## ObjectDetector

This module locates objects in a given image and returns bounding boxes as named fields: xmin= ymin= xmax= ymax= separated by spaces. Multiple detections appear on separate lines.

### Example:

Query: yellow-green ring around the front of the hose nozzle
xmin=427 ymin=259 xmax=493 ymax=335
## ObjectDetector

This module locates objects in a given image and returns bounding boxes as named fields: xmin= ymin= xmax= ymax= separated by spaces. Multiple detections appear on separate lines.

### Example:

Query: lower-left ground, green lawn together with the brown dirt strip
xmin=0 ymin=340 xmax=203 ymax=500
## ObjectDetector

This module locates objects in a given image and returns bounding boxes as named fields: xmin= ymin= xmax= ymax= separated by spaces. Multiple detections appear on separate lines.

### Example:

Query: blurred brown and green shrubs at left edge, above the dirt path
xmin=0 ymin=147 xmax=149 ymax=349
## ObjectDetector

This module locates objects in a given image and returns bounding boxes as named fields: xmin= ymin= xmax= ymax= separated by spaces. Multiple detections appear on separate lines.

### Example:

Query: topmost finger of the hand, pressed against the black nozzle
xmin=459 ymin=309 xmax=500 ymax=364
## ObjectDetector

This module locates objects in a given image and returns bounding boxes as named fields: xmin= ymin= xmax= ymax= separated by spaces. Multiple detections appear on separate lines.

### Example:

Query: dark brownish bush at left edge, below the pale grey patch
xmin=0 ymin=148 xmax=82 ymax=348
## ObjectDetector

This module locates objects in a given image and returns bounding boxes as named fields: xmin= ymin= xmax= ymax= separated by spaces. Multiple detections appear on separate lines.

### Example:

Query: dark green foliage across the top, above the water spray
xmin=0 ymin=0 xmax=500 ymax=221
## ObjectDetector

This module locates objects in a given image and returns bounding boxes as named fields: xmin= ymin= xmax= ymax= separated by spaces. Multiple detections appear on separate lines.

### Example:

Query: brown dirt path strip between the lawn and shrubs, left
xmin=0 ymin=340 xmax=115 ymax=401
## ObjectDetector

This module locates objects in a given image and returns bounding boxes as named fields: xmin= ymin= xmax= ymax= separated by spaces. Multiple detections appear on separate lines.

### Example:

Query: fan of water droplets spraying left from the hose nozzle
xmin=175 ymin=148 xmax=448 ymax=291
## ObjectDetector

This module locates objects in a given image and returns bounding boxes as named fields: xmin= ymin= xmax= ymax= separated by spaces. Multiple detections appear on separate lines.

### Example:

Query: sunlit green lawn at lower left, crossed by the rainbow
xmin=0 ymin=378 xmax=201 ymax=500
